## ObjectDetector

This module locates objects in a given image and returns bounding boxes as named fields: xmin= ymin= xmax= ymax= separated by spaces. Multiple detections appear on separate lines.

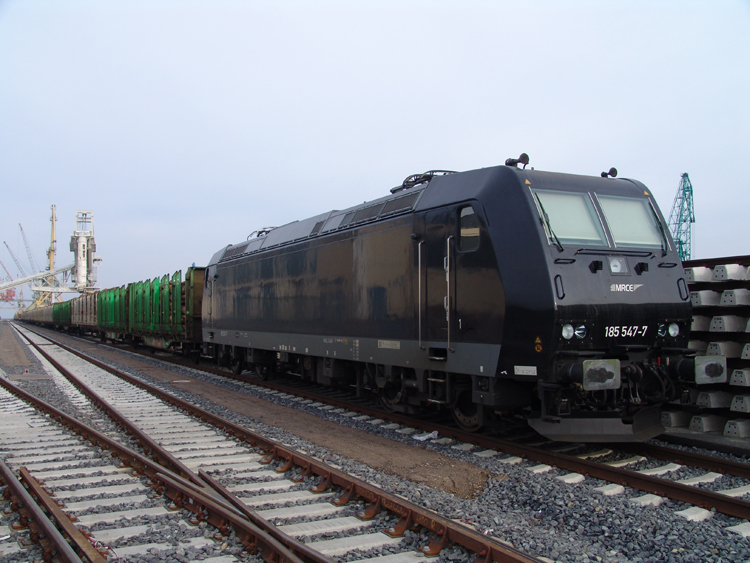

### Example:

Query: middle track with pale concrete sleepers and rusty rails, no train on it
xmin=2 ymin=331 xmax=535 ymax=563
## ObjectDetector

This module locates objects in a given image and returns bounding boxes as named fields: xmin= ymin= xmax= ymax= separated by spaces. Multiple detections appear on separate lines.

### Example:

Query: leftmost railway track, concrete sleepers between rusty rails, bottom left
xmin=0 ymin=366 xmax=298 ymax=563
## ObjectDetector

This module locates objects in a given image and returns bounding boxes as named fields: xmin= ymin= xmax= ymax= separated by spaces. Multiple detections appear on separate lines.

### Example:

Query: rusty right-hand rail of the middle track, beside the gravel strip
xmin=19 ymin=331 xmax=540 ymax=563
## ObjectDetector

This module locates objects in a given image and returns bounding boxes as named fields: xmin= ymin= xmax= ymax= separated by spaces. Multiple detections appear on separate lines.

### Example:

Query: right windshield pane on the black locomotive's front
xmin=597 ymin=195 xmax=663 ymax=248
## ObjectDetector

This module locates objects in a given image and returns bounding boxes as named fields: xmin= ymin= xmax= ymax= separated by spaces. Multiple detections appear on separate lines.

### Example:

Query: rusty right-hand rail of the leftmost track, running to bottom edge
xmin=0 ymin=377 xmax=310 ymax=563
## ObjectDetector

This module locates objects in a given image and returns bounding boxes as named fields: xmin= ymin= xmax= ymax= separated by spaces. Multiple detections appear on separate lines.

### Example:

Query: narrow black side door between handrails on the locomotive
xmin=422 ymin=209 xmax=455 ymax=360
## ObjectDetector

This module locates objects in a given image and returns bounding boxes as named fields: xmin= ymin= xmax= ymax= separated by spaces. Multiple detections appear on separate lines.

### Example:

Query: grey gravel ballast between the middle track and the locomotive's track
xmin=0 ymin=326 xmax=750 ymax=563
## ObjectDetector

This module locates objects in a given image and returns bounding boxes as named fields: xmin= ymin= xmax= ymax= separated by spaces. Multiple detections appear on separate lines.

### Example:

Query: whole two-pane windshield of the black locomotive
xmin=534 ymin=190 xmax=665 ymax=248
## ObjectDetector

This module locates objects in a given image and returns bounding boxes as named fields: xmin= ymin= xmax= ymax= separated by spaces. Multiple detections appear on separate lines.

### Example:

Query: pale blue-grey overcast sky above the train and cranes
xmin=0 ymin=0 xmax=750 ymax=317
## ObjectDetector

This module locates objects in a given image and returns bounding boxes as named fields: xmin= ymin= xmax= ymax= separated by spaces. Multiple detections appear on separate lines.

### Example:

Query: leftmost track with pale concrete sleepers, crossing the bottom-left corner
xmin=0 ymin=368 xmax=310 ymax=563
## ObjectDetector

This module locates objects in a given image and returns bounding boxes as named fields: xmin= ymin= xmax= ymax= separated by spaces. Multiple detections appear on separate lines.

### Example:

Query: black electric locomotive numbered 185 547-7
xmin=202 ymin=155 xmax=726 ymax=441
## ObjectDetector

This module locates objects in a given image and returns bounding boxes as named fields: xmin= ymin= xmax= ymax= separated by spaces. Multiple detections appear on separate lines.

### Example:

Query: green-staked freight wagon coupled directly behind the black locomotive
xmin=128 ymin=266 xmax=205 ymax=356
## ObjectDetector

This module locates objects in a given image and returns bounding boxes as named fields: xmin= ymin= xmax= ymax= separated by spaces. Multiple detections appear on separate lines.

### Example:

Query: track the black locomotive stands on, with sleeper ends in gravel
xmin=14 ymin=322 xmax=750 ymax=536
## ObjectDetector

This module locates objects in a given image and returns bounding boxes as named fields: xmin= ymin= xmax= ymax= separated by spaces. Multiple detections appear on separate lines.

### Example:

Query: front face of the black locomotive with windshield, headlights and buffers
xmin=502 ymin=171 xmax=726 ymax=441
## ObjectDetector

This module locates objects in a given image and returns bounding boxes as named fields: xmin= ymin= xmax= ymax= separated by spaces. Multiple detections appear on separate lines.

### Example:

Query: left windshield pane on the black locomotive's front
xmin=534 ymin=190 xmax=609 ymax=246
